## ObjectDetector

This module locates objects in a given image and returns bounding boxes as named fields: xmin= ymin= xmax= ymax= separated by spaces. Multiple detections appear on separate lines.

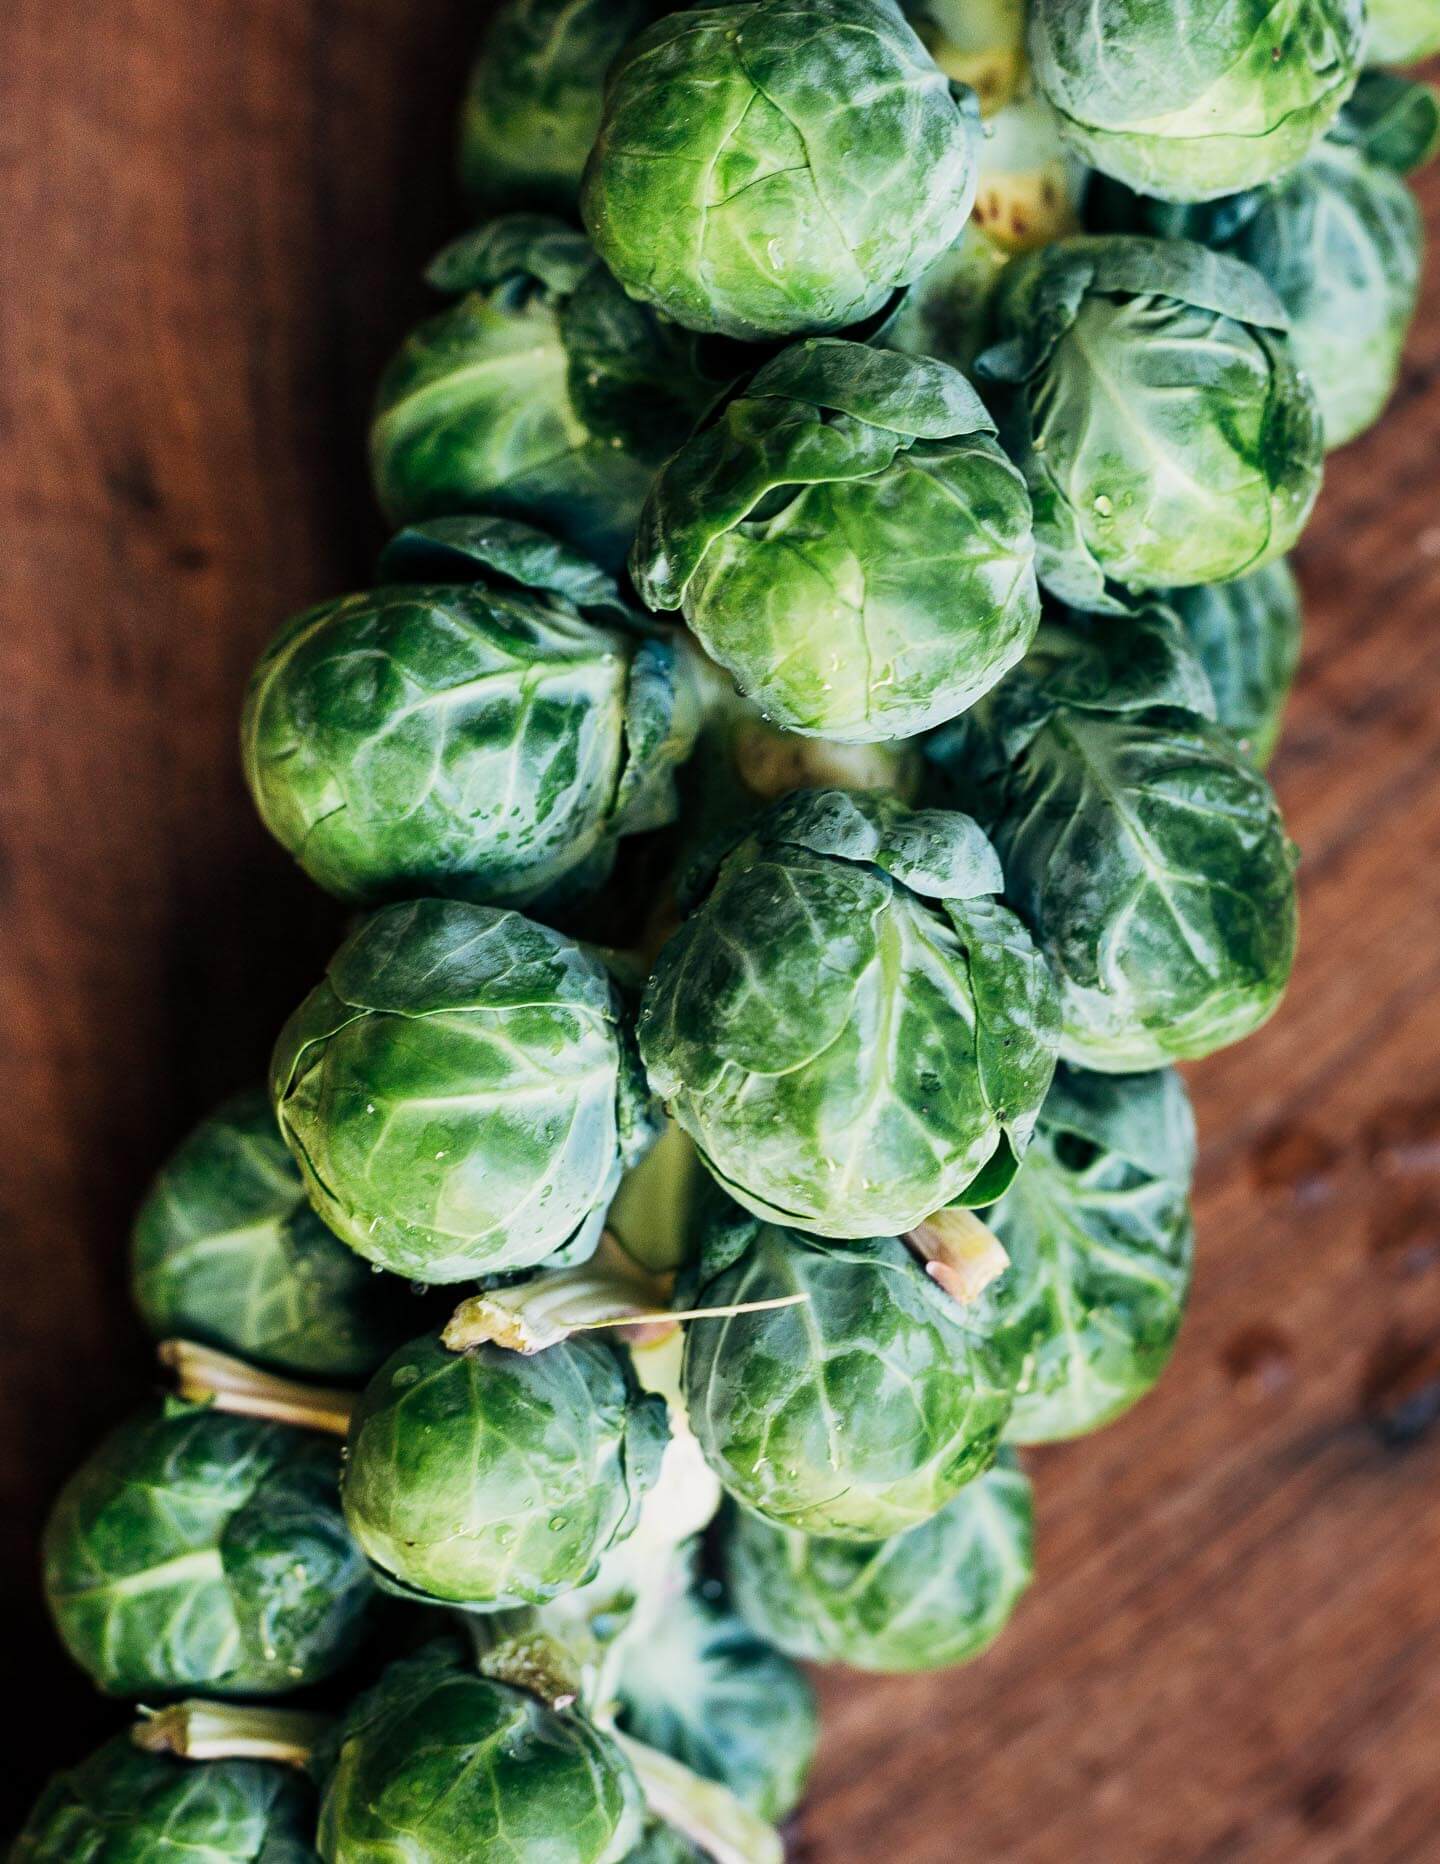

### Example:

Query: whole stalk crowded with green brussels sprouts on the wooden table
xmin=25 ymin=0 xmax=1440 ymax=1864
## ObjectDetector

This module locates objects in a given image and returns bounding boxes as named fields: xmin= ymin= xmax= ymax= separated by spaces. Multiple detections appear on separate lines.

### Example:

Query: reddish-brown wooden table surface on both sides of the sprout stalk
xmin=0 ymin=0 xmax=1440 ymax=1864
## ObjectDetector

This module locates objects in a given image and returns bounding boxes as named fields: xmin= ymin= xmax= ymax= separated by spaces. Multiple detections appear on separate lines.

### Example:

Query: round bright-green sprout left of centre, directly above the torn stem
xmin=272 ymin=900 xmax=652 ymax=1282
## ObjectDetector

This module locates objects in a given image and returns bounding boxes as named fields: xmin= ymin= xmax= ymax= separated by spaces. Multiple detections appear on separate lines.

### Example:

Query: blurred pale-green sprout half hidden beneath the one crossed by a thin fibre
xmin=727 ymin=1454 xmax=1034 ymax=1672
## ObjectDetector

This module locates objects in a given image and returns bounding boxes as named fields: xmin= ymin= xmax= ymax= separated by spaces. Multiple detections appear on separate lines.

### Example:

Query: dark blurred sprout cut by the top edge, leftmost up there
xmin=460 ymin=0 xmax=665 ymax=214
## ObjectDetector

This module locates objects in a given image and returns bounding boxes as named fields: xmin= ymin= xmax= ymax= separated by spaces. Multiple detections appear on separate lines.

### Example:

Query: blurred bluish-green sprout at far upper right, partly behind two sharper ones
xmin=1107 ymin=122 xmax=1425 ymax=447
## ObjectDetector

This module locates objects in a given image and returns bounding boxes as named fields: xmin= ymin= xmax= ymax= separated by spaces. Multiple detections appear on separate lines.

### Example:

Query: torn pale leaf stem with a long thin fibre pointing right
xmin=440 ymin=1232 xmax=808 ymax=1355
